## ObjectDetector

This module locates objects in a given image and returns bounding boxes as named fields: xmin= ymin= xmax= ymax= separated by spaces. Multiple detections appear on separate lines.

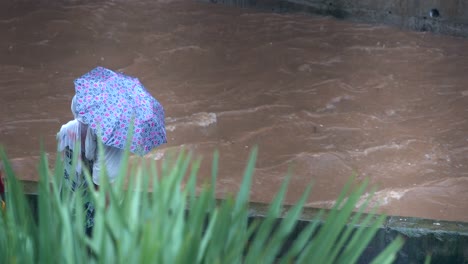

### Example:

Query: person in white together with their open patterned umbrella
xmin=57 ymin=67 xmax=167 ymax=232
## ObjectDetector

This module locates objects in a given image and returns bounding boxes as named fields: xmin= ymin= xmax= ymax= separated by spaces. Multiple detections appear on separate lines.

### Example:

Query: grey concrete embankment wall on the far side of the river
xmin=201 ymin=0 xmax=468 ymax=37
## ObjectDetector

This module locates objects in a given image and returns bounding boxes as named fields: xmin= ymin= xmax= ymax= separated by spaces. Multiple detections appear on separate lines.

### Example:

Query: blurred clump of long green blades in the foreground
xmin=0 ymin=146 xmax=403 ymax=264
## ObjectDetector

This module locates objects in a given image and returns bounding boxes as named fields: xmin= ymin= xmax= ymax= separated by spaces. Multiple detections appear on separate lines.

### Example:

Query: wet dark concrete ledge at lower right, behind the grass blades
xmin=250 ymin=203 xmax=468 ymax=264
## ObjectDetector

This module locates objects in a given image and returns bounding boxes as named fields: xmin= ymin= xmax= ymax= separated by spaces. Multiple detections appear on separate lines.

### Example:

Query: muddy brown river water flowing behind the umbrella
xmin=0 ymin=0 xmax=468 ymax=221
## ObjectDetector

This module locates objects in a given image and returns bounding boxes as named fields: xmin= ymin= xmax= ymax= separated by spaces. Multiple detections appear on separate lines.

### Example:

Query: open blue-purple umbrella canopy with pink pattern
xmin=75 ymin=67 xmax=167 ymax=155
